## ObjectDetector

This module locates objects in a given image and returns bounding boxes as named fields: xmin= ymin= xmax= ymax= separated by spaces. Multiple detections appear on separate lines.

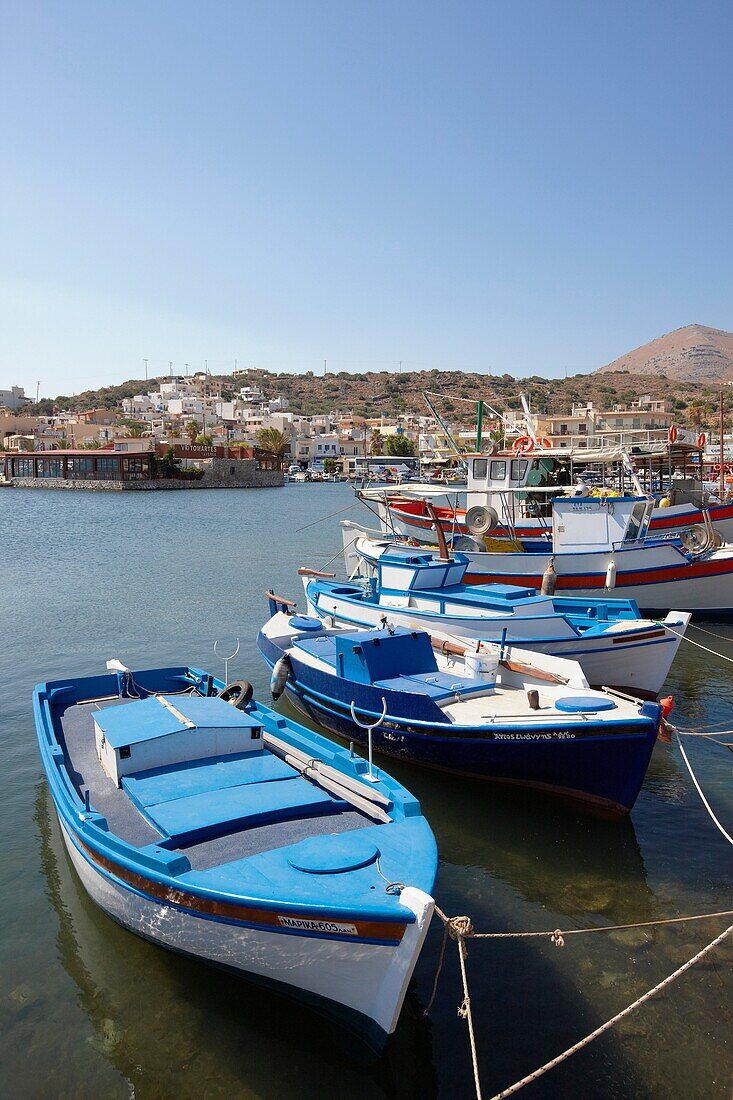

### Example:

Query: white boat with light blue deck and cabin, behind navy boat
xmin=300 ymin=546 xmax=690 ymax=699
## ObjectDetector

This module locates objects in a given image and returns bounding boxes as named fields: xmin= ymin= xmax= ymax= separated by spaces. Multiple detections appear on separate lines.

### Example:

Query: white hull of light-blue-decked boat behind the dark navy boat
xmin=306 ymin=589 xmax=689 ymax=696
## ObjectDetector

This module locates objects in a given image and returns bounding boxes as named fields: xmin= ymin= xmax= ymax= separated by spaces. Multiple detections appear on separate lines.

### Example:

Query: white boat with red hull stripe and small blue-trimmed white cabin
xmin=341 ymin=496 xmax=733 ymax=617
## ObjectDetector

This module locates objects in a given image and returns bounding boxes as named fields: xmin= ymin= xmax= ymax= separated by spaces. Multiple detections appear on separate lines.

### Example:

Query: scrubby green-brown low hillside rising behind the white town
xmin=28 ymin=363 xmax=733 ymax=426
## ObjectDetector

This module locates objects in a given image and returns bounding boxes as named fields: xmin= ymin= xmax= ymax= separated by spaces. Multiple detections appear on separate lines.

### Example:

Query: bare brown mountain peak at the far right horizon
xmin=595 ymin=325 xmax=733 ymax=383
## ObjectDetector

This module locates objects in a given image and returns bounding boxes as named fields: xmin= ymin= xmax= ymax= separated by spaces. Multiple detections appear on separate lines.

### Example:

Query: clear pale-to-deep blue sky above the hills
xmin=0 ymin=0 xmax=733 ymax=395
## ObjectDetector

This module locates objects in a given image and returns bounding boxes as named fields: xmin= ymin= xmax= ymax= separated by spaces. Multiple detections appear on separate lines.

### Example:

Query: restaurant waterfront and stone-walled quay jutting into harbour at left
xmin=0 ymin=440 xmax=284 ymax=492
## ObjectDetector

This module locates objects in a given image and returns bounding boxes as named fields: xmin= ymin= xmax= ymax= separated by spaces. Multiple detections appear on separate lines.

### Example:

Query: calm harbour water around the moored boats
xmin=0 ymin=485 xmax=733 ymax=1100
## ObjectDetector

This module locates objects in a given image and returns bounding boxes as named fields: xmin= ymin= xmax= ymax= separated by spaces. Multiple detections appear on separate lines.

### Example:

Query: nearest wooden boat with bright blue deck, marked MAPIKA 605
xmin=33 ymin=662 xmax=437 ymax=1048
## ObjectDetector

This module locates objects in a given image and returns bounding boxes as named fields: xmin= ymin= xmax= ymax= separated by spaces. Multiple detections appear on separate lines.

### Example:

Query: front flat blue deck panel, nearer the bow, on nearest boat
xmin=140 ymin=778 xmax=347 ymax=845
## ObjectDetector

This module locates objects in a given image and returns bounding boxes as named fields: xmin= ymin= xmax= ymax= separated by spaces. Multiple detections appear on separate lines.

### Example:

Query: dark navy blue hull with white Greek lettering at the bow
xmin=258 ymin=634 xmax=660 ymax=816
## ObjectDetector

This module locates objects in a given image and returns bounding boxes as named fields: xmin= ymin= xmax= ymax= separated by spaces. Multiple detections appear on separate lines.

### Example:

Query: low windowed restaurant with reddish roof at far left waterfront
xmin=0 ymin=450 xmax=151 ymax=482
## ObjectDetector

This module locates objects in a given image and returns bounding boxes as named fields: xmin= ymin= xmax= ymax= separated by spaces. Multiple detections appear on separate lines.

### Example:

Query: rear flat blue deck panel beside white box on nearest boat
xmin=122 ymin=749 xmax=297 ymax=810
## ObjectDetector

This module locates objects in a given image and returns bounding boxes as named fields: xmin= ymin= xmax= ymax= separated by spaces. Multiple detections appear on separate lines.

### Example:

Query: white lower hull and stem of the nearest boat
xmin=62 ymin=823 xmax=435 ymax=1035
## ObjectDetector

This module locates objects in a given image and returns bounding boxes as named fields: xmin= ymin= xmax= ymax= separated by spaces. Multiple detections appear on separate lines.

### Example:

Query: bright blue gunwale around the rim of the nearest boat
xmin=33 ymin=667 xmax=437 ymax=943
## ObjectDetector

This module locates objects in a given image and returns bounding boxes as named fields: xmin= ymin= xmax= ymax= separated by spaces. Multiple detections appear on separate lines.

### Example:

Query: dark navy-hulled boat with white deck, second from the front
xmin=258 ymin=611 xmax=660 ymax=816
